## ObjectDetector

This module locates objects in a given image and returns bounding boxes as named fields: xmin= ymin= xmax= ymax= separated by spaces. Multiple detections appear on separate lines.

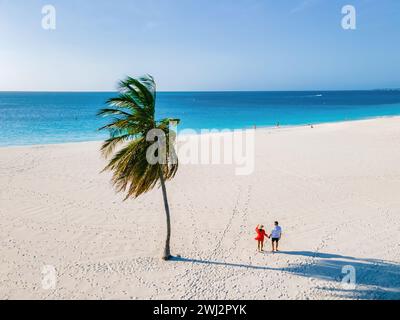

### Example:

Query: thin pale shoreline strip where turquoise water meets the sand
xmin=0 ymin=115 xmax=400 ymax=149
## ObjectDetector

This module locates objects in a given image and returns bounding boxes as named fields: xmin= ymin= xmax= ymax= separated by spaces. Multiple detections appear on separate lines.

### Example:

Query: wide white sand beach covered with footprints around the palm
xmin=0 ymin=117 xmax=400 ymax=299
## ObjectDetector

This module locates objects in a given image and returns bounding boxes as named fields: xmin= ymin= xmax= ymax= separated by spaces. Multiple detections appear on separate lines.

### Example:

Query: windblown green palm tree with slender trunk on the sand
xmin=98 ymin=75 xmax=179 ymax=260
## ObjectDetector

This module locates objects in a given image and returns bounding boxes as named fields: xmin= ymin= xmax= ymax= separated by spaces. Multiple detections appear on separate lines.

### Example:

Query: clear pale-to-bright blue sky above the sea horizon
xmin=0 ymin=0 xmax=400 ymax=91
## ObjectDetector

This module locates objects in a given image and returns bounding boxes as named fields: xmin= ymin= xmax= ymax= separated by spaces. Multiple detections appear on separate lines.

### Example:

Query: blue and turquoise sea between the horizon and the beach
xmin=0 ymin=90 xmax=400 ymax=146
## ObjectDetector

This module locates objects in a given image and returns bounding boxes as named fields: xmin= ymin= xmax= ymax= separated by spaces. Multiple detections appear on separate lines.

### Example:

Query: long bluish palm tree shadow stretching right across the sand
xmin=173 ymin=251 xmax=400 ymax=300
